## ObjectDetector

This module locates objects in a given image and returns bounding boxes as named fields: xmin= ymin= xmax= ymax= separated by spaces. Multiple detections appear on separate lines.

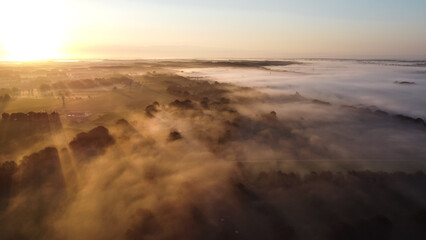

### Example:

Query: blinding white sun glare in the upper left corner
xmin=0 ymin=0 xmax=66 ymax=61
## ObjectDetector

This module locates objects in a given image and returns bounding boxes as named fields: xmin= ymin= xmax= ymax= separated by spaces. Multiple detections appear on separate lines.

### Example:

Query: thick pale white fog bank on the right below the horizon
xmin=185 ymin=60 xmax=426 ymax=118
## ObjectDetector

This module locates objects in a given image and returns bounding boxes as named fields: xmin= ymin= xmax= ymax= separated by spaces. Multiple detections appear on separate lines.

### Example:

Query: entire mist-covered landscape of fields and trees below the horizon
xmin=0 ymin=59 xmax=426 ymax=239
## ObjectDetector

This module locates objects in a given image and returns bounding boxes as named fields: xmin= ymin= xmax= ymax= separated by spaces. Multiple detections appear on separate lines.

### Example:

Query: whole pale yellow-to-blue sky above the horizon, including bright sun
xmin=0 ymin=0 xmax=426 ymax=60
